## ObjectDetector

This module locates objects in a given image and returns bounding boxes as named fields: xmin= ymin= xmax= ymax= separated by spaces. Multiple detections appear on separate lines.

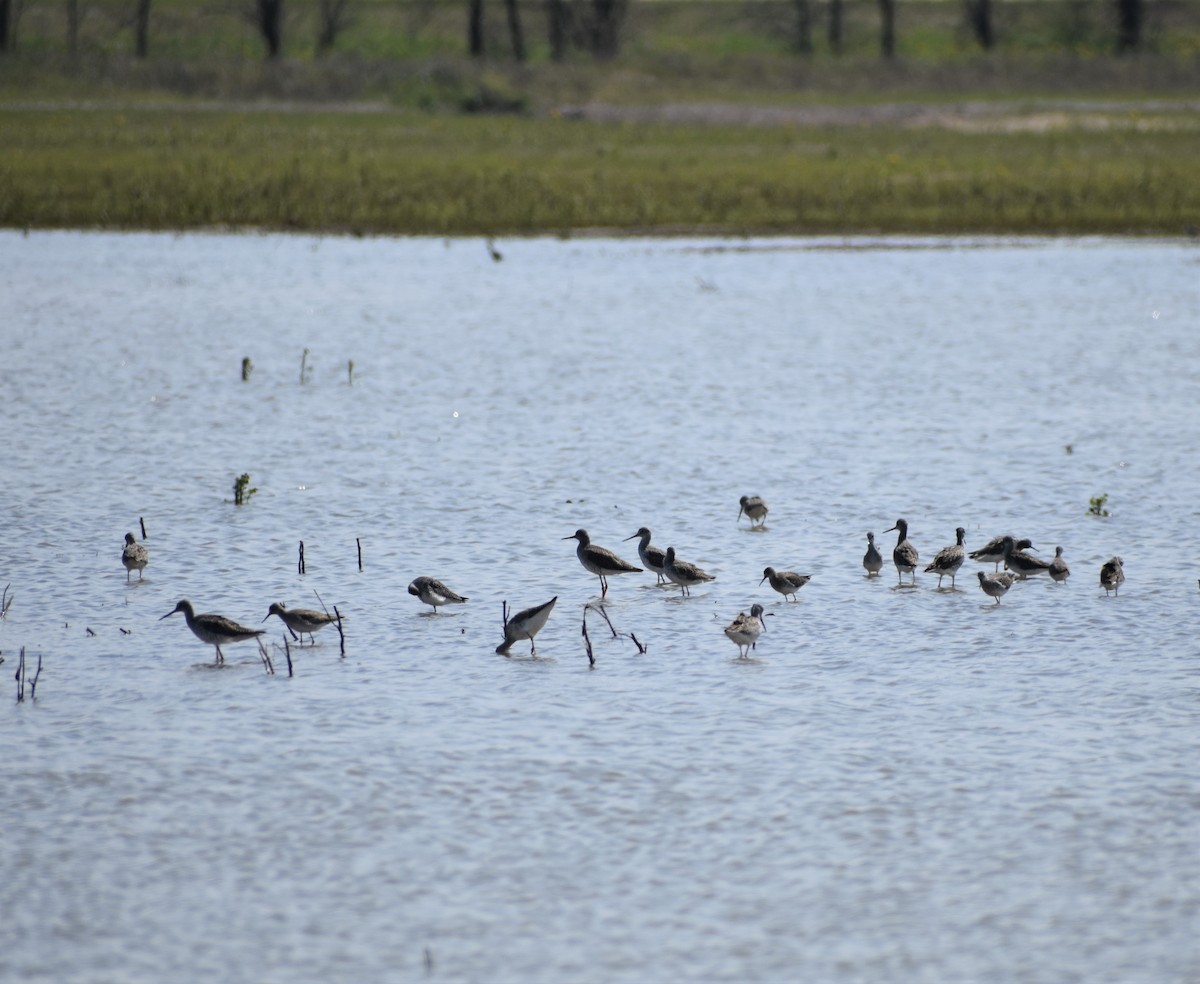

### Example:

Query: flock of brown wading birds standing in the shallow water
xmin=131 ymin=496 xmax=1124 ymax=664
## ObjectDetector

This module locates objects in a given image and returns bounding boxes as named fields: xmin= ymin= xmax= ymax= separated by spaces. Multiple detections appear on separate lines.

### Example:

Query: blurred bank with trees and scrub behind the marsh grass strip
xmin=0 ymin=0 xmax=1200 ymax=110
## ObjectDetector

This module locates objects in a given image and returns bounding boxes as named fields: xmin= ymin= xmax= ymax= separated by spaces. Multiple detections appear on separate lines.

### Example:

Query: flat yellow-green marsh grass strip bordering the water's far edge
xmin=0 ymin=108 xmax=1200 ymax=235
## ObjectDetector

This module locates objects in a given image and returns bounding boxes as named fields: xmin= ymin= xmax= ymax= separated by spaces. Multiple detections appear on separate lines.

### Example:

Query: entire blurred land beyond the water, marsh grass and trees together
xmin=0 ymin=0 xmax=1200 ymax=238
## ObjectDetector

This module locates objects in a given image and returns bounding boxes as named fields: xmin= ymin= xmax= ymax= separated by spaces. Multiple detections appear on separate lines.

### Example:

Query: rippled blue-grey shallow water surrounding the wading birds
xmin=0 ymin=233 xmax=1200 ymax=982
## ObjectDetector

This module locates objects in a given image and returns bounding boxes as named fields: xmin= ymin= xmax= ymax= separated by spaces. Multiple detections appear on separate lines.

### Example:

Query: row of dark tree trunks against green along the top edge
xmin=0 ymin=0 xmax=1200 ymax=61
